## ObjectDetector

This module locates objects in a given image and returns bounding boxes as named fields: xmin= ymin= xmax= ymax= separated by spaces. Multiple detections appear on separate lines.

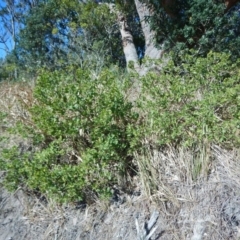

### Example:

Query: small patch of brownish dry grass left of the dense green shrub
xmin=0 ymin=81 xmax=34 ymax=158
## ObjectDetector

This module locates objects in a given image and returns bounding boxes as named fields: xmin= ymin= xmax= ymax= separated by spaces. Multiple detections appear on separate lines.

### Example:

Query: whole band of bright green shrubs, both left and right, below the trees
xmin=0 ymin=52 xmax=240 ymax=202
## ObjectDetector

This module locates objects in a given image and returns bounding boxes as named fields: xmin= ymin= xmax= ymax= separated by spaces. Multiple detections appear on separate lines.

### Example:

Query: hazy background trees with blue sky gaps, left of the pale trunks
xmin=17 ymin=0 xmax=144 ymax=71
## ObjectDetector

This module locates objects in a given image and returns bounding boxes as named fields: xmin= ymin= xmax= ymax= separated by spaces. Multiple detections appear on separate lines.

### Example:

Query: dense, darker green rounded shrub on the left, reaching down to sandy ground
xmin=1 ymin=69 xmax=138 ymax=201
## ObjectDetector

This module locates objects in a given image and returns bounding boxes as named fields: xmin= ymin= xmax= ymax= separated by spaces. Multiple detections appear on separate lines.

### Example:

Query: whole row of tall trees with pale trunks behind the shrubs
xmin=0 ymin=0 xmax=240 ymax=76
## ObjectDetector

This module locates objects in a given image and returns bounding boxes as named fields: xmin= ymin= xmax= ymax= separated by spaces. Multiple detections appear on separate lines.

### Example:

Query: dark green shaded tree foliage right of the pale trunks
xmin=142 ymin=0 xmax=240 ymax=57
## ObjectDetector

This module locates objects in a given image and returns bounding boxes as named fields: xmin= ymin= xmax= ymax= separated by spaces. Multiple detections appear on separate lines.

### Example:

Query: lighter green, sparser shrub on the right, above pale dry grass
xmin=138 ymin=53 xmax=240 ymax=147
